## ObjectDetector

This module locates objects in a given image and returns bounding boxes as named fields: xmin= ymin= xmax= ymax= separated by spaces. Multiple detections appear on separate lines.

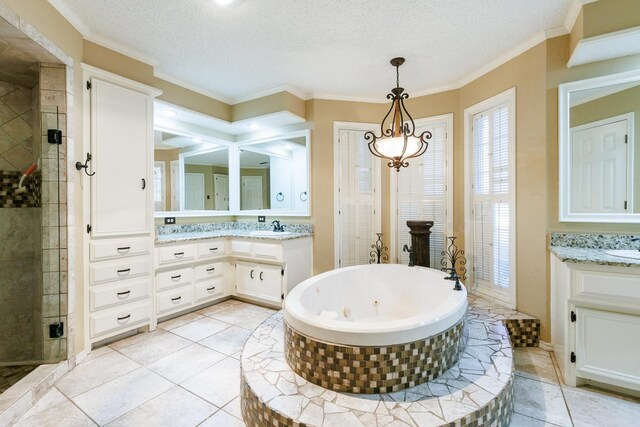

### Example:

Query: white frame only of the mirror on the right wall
xmin=558 ymin=70 xmax=640 ymax=224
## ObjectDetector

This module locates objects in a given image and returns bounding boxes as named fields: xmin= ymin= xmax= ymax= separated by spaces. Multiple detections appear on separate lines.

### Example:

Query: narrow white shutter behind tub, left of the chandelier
xmin=338 ymin=130 xmax=375 ymax=267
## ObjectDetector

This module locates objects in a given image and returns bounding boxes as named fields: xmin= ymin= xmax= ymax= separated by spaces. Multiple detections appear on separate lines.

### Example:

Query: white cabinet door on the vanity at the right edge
xmin=576 ymin=307 xmax=640 ymax=390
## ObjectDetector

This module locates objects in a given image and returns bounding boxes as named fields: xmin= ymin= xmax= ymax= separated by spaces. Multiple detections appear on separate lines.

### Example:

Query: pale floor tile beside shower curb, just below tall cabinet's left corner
xmin=56 ymin=351 xmax=140 ymax=397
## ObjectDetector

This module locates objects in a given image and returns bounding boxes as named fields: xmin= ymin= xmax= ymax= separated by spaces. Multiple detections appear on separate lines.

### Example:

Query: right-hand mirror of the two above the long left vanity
xmin=238 ymin=132 xmax=309 ymax=214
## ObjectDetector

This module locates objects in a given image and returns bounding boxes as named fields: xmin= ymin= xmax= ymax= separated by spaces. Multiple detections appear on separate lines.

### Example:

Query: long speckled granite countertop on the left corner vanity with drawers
xmin=156 ymin=222 xmax=313 ymax=245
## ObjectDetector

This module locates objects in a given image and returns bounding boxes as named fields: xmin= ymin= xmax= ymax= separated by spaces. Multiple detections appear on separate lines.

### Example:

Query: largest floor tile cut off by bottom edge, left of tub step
xmin=109 ymin=386 xmax=218 ymax=427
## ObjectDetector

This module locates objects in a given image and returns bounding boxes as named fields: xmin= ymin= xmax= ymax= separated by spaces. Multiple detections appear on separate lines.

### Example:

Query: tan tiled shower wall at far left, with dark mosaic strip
xmin=0 ymin=64 xmax=68 ymax=364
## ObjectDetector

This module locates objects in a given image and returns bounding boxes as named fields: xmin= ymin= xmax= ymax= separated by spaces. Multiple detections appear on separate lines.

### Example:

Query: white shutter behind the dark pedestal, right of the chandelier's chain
xmin=396 ymin=123 xmax=447 ymax=268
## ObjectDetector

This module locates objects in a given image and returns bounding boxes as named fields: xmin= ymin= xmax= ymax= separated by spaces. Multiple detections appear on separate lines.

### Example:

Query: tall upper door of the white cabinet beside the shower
xmin=89 ymin=77 xmax=153 ymax=237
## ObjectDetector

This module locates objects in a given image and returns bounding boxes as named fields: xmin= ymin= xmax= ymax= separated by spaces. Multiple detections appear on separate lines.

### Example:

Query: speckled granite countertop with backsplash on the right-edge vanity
xmin=549 ymin=233 xmax=640 ymax=268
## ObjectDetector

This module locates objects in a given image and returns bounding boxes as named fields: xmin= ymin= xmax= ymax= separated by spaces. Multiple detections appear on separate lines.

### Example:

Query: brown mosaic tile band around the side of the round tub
xmin=284 ymin=320 xmax=464 ymax=394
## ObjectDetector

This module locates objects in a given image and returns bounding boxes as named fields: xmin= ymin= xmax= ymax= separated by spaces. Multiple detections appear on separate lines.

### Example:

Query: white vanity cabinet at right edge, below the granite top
xmin=551 ymin=255 xmax=640 ymax=391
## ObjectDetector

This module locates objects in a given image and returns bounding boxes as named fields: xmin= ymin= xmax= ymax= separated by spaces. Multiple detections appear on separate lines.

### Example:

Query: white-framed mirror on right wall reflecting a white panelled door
xmin=559 ymin=70 xmax=640 ymax=222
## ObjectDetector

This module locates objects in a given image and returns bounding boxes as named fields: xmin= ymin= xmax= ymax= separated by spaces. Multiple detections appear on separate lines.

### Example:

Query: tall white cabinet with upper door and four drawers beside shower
xmin=80 ymin=64 xmax=161 ymax=345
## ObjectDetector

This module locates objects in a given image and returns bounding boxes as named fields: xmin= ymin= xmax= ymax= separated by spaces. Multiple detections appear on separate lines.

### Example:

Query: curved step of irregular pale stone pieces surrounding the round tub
xmin=241 ymin=297 xmax=537 ymax=427
